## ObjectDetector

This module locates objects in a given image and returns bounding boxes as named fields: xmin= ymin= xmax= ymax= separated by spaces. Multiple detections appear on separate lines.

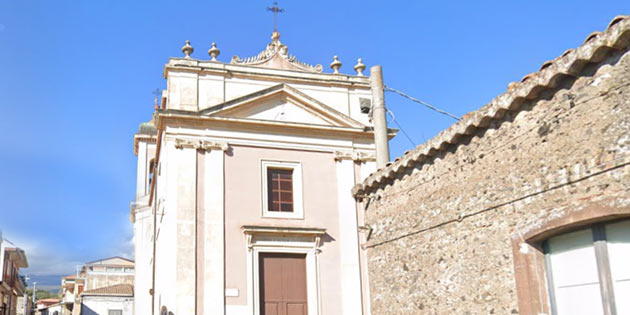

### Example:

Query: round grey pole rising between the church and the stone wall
xmin=370 ymin=65 xmax=389 ymax=169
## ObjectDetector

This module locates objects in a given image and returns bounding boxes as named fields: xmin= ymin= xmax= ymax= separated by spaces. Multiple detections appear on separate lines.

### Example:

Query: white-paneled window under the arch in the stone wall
xmin=543 ymin=221 xmax=630 ymax=315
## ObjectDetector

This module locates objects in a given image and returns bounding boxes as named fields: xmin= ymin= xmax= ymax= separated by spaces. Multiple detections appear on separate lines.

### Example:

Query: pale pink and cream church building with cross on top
xmin=131 ymin=31 xmax=394 ymax=315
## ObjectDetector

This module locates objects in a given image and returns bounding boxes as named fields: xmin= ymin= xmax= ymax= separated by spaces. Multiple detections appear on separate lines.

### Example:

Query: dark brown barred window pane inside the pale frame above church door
xmin=267 ymin=168 xmax=293 ymax=212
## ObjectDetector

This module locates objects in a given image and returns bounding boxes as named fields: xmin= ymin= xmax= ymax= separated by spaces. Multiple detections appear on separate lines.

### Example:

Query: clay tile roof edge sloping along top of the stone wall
xmin=352 ymin=16 xmax=630 ymax=199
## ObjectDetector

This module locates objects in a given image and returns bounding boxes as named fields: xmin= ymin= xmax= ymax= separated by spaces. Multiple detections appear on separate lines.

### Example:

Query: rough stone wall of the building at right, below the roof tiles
xmin=364 ymin=51 xmax=630 ymax=314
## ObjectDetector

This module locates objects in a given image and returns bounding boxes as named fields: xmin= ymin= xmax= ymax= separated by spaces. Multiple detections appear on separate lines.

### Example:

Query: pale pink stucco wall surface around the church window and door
xmin=225 ymin=145 xmax=341 ymax=314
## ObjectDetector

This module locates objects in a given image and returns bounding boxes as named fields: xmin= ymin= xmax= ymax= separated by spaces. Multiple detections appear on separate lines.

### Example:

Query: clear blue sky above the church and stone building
xmin=0 ymin=0 xmax=630 ymax=286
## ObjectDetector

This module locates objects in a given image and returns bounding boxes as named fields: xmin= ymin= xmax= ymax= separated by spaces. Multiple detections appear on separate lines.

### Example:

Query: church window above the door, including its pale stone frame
xmin=261 ymin=161 xmax=304 ymax=219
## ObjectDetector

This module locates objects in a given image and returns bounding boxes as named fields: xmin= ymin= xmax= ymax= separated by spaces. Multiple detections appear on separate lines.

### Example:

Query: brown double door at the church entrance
xmin=258 ymin=253 xmax=307 ymax=315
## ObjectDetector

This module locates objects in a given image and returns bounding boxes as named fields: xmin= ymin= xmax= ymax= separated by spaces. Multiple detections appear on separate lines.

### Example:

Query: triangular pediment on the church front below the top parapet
xmin=201 ymin=84 xmax=365 ymax=128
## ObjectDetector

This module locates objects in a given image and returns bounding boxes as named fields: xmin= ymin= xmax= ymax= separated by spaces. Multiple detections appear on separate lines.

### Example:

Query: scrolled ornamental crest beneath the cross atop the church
xmin=230 ymin=32 xmax=323 ymax=73
